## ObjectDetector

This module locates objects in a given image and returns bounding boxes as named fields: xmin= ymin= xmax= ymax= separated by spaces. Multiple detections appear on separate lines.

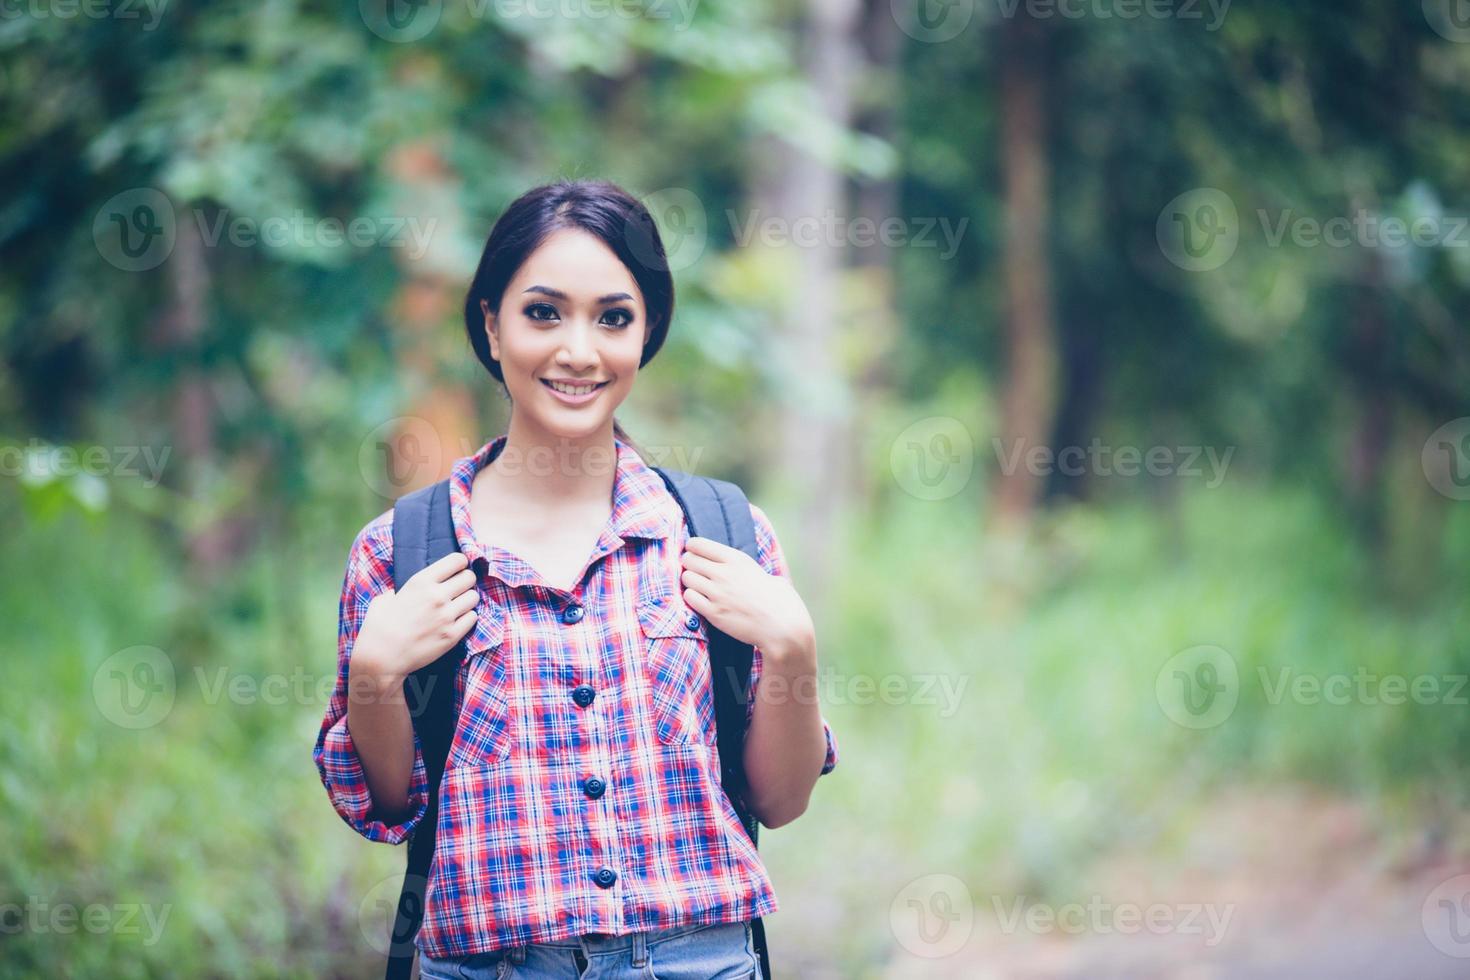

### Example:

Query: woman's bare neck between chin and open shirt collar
xmin=487 ymin=411 xmax=617 ymax=505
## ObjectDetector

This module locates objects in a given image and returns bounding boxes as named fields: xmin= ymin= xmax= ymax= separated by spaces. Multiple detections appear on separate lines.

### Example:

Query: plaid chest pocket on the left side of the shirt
xmin=445 ymin=602 xmax=510 ymax=768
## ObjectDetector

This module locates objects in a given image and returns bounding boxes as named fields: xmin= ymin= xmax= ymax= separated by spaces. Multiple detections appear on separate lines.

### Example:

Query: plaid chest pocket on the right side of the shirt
xmin=638 ymin=594 xmax=714 ymax=745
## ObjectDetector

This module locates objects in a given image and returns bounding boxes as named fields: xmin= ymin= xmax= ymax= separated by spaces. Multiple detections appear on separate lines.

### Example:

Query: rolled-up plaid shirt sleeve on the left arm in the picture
xmin=313 ymin=510 xmax=429 ymax=843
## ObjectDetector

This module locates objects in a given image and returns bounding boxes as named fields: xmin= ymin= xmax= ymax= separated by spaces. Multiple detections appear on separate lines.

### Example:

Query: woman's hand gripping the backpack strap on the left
xmin=350 ymin=551 xmax=479 ymax=682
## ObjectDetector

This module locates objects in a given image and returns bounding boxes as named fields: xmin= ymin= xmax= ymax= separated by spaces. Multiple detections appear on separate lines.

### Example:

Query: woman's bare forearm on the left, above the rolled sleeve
xmin=347 ymin=661 xmax=413 ymax=823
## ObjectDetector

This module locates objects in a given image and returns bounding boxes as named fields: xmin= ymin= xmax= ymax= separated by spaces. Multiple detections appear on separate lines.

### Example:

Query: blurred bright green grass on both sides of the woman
xmin=0 ymin=485 xmax=1470 ymax=977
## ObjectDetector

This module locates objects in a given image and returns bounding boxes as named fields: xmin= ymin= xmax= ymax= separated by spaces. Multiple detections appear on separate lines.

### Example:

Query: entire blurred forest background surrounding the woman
xmin=0 ymin=0 xmax=1470 ymax=979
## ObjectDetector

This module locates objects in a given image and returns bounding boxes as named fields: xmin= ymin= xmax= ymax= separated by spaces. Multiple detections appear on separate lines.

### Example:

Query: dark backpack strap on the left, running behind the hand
xmin=387 ymin=480 xmax=465 ymax=980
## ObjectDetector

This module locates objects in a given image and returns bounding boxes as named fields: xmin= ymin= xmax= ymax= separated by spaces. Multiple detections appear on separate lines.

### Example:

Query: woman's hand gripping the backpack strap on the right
xmin=679 ymin=536 xmax=816 ymax=658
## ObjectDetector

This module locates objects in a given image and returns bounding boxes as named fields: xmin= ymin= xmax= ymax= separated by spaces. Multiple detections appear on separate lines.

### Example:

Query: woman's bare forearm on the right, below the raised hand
xmin=744 ymin=636 xmax=826 ymax=827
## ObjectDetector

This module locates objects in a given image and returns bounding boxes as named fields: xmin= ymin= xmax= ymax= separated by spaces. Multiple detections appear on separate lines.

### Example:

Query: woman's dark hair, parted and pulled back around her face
xmin=465 ymin=179 xmax=673 ymax=442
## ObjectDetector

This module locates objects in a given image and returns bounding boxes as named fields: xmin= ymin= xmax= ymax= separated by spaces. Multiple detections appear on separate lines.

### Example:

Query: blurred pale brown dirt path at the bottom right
xmin=882 ymin=790 xmax=1470 ymax=980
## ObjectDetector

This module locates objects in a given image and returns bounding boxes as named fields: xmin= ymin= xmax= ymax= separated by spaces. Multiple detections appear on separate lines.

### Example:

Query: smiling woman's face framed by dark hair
xmin=481 ymin=228 xmax=648 ymax=439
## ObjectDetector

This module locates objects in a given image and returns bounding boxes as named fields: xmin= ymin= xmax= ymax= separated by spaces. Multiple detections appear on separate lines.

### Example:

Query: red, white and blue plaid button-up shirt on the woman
xmin=315 ymin=435 xmax=836 ymax=956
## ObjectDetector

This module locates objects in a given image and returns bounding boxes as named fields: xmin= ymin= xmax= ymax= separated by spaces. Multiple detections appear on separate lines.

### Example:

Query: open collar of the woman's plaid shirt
xmin=450 ymin=435 xmax=684 ymax=586
